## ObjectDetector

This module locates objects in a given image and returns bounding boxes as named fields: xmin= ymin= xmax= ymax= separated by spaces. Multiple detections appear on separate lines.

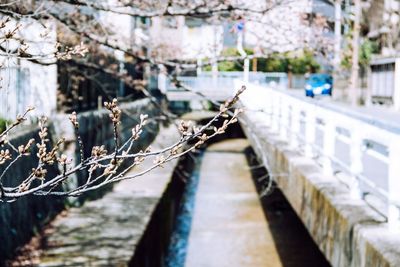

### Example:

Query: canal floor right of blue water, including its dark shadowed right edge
xmin=185 ymin=139 xmax=329 ymax=267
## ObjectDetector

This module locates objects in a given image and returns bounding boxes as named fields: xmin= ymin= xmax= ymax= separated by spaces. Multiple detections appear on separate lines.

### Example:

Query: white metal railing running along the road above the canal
xmin=235 ymin=81 xmax=400 ymax=229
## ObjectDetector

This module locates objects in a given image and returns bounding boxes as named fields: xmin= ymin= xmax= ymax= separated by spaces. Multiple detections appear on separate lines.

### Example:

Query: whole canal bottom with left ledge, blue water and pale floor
xmin=10 ymin=130 xmax=329 ymax=267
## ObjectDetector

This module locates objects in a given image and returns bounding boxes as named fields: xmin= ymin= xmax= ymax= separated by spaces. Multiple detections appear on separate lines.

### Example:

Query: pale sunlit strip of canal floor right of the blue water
xmin=185 ymin=139 xmax=279 ymax=267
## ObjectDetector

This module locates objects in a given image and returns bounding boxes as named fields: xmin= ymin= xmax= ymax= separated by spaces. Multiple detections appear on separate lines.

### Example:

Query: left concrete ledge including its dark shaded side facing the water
xmin=37 ymin=126 xmax=184 ymax=267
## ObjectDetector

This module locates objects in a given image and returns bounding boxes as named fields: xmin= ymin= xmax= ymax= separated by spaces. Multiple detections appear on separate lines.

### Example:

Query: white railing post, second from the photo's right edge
xmin=350 ymin=129 xmax=363 ymax=199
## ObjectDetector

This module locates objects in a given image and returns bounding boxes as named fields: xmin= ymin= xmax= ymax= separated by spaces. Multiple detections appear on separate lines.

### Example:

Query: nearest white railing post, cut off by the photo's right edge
xmin=388 ymin=138 xmax=400 ymax=232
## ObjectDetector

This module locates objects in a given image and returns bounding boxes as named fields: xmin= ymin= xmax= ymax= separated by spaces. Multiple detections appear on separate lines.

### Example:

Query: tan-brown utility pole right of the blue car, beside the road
xmin=349 ymin=0 xmax=361 ymax=106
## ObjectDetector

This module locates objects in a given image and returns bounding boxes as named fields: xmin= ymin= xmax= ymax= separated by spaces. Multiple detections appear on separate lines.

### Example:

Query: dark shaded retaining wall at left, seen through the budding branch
xmin=0 ymin=99 xmax=159 ymax=266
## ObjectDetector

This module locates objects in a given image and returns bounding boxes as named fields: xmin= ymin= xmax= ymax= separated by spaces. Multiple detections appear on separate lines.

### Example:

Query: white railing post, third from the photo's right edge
xmin=322 ymin=116 xmax=336 ymax=175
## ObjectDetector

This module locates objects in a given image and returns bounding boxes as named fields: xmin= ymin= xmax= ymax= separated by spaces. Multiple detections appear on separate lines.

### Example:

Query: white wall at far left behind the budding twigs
xmin=0 ymin=20 xmax=57 ymax=120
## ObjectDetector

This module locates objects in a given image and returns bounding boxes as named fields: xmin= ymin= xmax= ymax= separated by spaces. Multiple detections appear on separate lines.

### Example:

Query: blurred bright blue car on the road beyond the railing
xmin=304 ymin=73 xmax=333 ymax=97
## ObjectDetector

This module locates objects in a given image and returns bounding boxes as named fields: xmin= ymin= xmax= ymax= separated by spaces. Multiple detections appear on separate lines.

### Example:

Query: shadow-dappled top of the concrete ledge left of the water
xmin=39 ymin=127 xmax=179 ymax=266
